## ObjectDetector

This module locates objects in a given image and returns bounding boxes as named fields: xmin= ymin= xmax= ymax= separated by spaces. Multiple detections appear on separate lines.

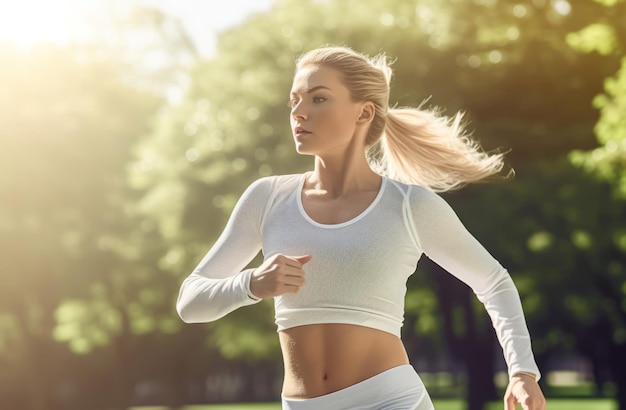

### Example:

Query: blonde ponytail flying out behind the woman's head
xmin=368 ymin=108 xmax=512 ymax=192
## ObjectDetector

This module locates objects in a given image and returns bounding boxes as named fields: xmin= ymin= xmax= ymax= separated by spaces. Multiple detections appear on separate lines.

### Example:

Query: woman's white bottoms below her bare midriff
xmin=282 ymin=364 xmax=435 ymax=410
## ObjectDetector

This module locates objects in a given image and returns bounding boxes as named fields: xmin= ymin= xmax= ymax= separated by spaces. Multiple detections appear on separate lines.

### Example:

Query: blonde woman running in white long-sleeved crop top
xmin=177 ymin=47 xmax=545 ymax=410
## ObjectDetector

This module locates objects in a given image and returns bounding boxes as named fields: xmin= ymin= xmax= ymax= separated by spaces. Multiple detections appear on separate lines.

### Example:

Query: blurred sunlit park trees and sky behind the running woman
xmin=0 ymin=0 xmax=626 ymax=410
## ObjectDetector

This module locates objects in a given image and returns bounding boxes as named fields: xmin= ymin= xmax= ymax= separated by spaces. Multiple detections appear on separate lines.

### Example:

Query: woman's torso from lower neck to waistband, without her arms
xmin=263 ymin=176 xmax=421 ymax=398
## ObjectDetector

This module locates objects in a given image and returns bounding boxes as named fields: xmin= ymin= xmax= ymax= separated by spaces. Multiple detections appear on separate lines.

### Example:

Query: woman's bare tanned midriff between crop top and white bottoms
xmin=279 ymin=324 xmax=409 ymax=399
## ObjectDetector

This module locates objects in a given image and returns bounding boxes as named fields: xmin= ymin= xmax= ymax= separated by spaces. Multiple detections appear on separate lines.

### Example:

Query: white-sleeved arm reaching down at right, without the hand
xmin=411 ymin=188 xmax=541 ymax=380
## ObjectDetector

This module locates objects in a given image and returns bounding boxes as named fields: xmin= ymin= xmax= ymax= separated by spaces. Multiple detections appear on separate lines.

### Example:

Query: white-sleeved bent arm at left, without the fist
xmin=176 ymin=178 xmax=272 ymax=323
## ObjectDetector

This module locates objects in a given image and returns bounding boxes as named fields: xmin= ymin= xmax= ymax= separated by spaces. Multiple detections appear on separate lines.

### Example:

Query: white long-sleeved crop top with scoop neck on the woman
xmin=177 ymin=174 xmax=540 ymax=377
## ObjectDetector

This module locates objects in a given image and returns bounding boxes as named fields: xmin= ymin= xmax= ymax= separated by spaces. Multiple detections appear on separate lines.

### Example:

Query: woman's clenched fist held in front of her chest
xmin=250 ymin=254 xmax=311 ymax=298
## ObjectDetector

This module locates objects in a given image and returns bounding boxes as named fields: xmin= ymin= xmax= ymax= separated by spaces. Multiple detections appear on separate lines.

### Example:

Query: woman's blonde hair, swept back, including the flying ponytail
xmin=296 ymin=47 xmax=503 ymax=192
